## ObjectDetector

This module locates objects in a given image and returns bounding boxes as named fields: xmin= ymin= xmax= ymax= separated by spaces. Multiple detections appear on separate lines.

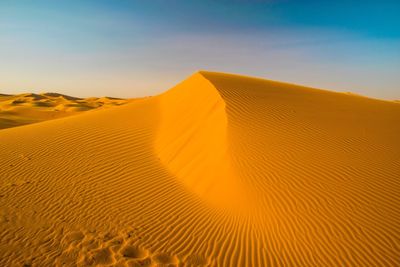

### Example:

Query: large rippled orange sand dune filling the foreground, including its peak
xmin=0 ymin=72 xmax=400 ymax=266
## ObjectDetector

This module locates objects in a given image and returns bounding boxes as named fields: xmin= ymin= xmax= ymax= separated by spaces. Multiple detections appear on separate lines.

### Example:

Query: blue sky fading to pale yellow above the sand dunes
xmin=0 ymin=0 xmax=400 ymax=100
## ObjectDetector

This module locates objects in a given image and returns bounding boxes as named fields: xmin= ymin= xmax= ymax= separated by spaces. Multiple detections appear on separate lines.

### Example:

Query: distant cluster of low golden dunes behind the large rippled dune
xmin=0 ymin=93 xmax=132 ymax=129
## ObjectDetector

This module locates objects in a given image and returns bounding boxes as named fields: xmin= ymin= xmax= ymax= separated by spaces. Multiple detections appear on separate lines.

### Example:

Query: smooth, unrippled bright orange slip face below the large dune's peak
xmin=155 ymin=73 xmax=243 ymax=209
